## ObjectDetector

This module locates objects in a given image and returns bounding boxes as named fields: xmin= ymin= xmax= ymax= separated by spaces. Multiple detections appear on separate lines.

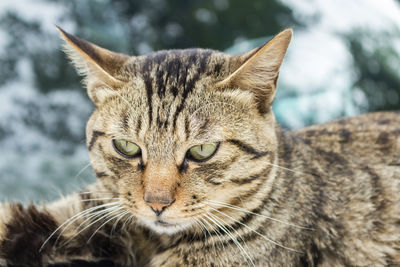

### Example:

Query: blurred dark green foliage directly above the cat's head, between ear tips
xmin=58 ymin=0 xmax=298 ymax=54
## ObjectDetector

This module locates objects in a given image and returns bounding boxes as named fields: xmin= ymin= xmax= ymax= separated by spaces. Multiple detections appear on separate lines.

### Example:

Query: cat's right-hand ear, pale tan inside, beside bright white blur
xmin=217 ymin=29 xmax=293 ymax=114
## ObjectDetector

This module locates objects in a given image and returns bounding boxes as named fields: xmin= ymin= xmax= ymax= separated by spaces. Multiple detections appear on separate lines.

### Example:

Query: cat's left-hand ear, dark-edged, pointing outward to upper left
xmin=57 ymin=27 xmax=129 ymax=105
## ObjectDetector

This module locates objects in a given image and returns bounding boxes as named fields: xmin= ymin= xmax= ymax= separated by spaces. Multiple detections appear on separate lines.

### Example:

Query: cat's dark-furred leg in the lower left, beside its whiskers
xmin=0 ymin=183 xmax=134 ymax=266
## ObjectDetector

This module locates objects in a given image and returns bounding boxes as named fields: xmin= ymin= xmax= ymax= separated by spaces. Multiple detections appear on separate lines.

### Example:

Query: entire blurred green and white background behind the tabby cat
xmin=0 ymin=0 xmax=400 ymax=202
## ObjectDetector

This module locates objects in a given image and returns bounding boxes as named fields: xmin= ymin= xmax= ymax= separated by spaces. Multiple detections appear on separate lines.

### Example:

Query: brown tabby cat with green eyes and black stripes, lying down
xmin=0 ymin=28 xmax=400 ymax=266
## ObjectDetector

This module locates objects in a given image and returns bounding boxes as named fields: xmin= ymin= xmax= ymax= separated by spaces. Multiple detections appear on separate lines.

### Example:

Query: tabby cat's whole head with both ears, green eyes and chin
xmin=60 ymin=29 xmax=292 ymax=233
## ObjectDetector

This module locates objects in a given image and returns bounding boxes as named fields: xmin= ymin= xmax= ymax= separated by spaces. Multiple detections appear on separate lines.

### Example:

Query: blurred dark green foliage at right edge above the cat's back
xmin=347 ymin=31 xmax=400 ymax=112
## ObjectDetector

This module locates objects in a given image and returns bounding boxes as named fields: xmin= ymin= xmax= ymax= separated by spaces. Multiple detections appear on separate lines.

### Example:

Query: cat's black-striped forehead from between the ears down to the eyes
xmin=102 ymin=49 xmax=255 ymax=150
